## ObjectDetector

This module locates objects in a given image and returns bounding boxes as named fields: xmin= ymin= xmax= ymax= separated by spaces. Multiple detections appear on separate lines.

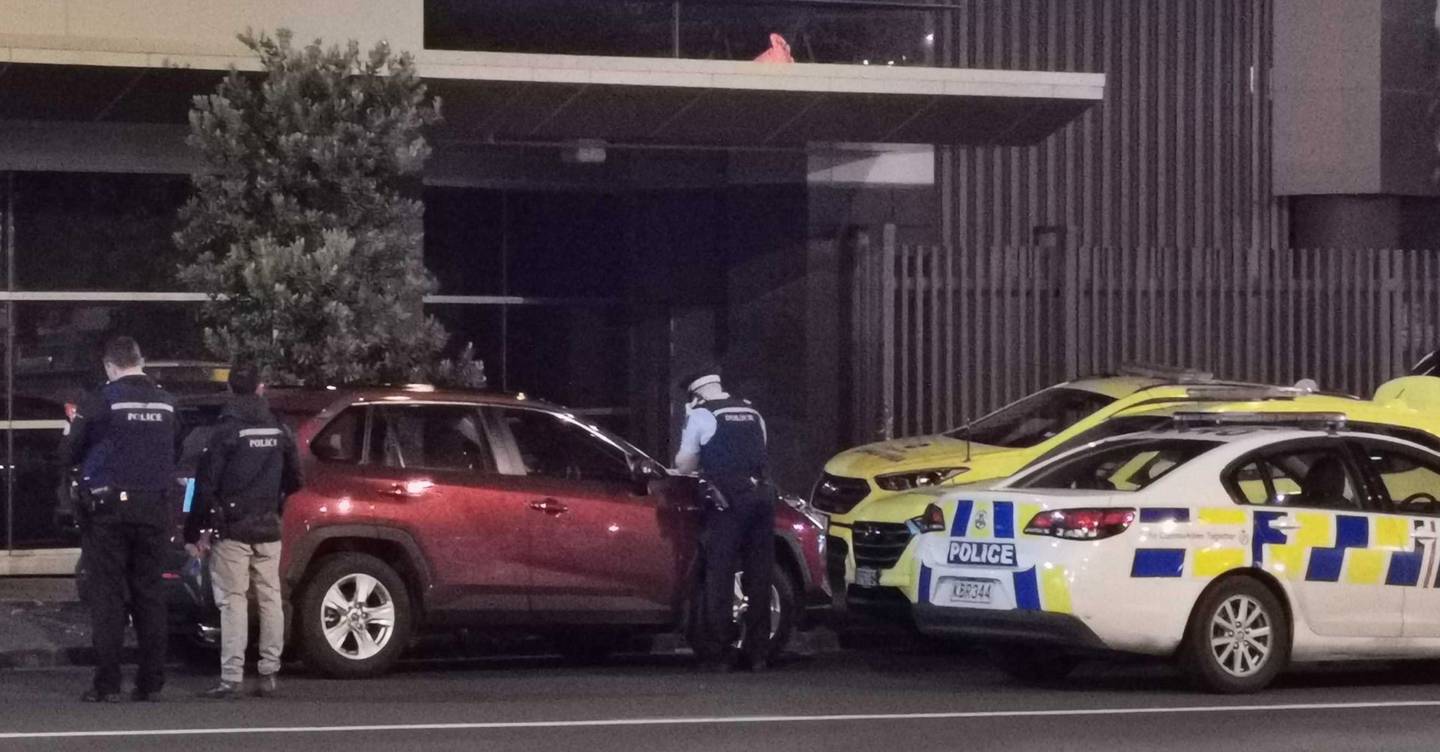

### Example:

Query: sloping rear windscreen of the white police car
xmin=1011 ymin=439 xmax=1220 ymax=491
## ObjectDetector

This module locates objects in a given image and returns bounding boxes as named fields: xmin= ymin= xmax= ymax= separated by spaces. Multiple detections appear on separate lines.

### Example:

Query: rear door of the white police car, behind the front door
xmin=1230 ymin=437 xmax=1404 ymax=637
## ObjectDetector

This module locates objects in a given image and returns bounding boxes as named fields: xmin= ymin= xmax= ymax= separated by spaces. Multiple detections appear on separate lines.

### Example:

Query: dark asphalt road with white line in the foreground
xmin=0 ymin=636 xmax=1440 ymax=752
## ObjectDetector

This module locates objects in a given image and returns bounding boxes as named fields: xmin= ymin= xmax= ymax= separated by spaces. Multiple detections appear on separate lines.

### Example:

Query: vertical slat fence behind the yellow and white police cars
xmin=850 ymin=230 xmax=1440 ymax=442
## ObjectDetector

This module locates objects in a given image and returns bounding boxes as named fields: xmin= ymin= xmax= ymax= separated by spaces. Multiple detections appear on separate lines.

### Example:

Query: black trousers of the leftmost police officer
xmin=81 ymin=519 xmax=170 ymax=694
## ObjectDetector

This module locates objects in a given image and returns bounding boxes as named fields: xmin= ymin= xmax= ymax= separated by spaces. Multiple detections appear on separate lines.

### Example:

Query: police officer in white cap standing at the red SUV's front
xmin=675 ymin=369 xmax=775 ymax=671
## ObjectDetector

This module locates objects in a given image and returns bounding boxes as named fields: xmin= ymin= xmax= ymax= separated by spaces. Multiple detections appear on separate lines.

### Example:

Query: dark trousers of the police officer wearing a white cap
xmin=696 ymin=494 xmax=775 ymax=660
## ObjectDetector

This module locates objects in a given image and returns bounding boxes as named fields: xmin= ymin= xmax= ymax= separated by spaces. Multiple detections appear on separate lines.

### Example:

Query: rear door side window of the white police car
xmin=1227 ymin=445 xmax=1364 ymax=511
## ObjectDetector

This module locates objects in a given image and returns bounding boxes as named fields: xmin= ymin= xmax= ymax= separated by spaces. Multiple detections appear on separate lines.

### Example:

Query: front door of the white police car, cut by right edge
xmin=1354 ymin=439 xmax=1440 ymax=637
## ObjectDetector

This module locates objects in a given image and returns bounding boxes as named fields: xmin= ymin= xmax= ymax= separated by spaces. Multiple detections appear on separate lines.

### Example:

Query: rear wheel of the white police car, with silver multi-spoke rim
xmin=1181 ymin=576 xmax=1290 ymax=694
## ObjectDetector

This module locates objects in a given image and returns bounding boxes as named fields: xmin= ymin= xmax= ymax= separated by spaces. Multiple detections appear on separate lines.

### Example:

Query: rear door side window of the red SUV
xmin=370 ymin=405 xmax=495 ymax=473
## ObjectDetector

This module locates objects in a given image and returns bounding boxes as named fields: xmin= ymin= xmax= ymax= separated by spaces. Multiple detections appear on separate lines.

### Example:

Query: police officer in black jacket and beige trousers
xmin=184 ymin=364 xmax=301 ymax=699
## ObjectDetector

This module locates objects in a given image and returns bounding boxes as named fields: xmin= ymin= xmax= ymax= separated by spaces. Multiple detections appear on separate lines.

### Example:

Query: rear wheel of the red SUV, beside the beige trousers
xmin=298 ymin=553 xmax=412 ymax=679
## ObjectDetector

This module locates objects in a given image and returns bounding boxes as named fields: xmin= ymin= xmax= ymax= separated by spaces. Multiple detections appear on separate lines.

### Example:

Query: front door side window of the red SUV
xmin=495 ymin=408 xmax=631 ymax=483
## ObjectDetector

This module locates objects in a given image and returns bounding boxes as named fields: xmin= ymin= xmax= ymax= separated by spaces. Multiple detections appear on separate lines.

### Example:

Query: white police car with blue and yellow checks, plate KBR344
xmin=909 ymin=415 xmax=1440 ymax=691
